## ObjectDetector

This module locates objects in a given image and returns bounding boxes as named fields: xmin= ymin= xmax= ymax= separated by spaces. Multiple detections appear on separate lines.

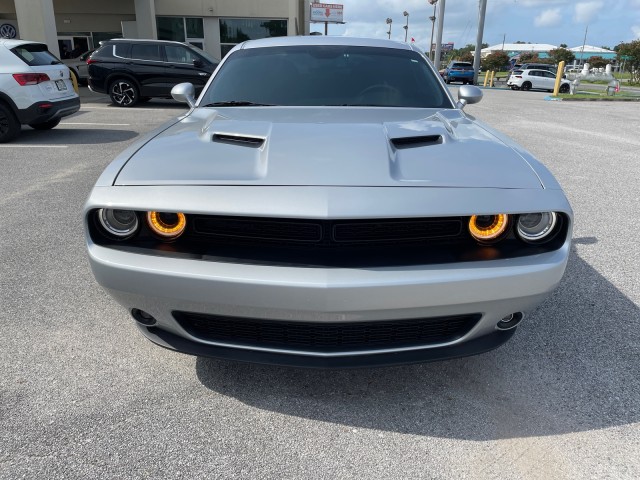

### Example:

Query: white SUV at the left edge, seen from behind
xmin=0 ymin=39 xmax=80 ymax=143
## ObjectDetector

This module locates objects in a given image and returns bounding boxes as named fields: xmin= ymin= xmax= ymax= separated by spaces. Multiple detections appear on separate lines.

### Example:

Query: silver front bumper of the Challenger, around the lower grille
xmin=89 ymin=237 xmax=569 ymax=367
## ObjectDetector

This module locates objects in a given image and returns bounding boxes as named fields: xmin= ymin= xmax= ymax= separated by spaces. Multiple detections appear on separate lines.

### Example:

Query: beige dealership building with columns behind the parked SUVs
xmin=0 ymin=0 xmax=310 ymax=58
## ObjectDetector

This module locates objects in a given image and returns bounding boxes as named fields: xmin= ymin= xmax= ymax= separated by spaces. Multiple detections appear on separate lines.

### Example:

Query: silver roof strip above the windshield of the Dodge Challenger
xmin=232 ymin=35 xmax=419 ymax=51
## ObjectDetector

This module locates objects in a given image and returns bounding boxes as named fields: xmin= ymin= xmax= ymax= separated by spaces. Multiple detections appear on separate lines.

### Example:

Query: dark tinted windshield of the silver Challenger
xmin=200 ymin=45 xmax=453 ymax=108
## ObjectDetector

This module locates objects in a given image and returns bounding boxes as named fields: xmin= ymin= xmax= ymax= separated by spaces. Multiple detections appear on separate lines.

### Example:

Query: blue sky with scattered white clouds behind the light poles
xmin=311 ymin=0 xmax=640 ymax=50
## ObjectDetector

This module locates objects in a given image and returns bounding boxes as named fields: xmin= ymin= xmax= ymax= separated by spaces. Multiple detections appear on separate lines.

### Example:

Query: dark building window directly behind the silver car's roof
xmin=220 ymin=18 xmax=287 ymax=57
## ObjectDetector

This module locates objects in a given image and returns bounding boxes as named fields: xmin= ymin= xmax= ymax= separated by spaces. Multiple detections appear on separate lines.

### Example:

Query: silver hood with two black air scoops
xmin=114 ymin=107 xmax=542 ymax=189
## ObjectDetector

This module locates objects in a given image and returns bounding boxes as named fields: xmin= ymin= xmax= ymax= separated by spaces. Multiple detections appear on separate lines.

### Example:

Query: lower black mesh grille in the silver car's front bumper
xmin=173 ymin=312 xmax=480 ymax=353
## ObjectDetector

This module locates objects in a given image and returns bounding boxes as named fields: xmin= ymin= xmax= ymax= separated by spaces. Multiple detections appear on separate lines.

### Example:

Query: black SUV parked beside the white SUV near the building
xmin=87 ymin=39 xmax=219 ymax=107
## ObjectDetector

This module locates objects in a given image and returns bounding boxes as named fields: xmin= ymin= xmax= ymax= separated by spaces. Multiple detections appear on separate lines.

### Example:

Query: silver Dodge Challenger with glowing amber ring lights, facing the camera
xmin=84 ymin=36 xmax=573 ymax=368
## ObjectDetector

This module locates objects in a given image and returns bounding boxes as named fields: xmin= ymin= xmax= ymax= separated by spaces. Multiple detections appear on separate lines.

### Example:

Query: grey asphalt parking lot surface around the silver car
xmin=0 ymin=85 xmax=640 ymax=479
